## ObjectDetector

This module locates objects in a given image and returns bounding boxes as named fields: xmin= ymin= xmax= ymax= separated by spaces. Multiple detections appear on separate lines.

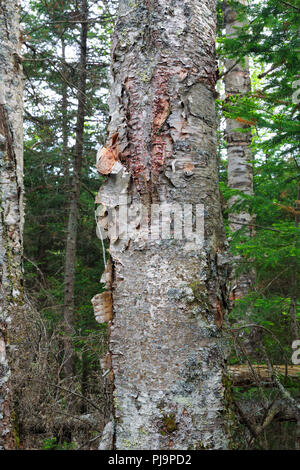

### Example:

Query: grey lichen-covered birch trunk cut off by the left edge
xmin=0 ymin=0 xmax=23 ymax=449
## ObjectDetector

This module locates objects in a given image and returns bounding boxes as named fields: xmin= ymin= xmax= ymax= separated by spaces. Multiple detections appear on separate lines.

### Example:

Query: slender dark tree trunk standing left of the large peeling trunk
xmin=64 ymin=0 xmax=88 ymax=377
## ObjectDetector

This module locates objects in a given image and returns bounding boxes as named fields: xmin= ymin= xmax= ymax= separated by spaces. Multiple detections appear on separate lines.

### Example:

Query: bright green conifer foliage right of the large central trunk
xmin=218 ymin=0 xmax=300 ymax=382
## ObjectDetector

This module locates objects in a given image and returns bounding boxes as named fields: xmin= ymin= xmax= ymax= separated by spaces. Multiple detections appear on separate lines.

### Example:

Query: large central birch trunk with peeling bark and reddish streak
xmin=94 ymin=0 xmax=228 ymax=449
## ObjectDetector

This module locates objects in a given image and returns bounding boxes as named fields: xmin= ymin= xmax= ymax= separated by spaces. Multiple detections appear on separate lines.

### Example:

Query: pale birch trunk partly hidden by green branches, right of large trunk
xmin=224 ymin=0 xmax=255 ymax=299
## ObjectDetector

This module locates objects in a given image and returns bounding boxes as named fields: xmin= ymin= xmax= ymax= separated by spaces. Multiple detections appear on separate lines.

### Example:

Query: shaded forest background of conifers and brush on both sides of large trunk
xmin=13 ymin=0 xmax=300 ymax=449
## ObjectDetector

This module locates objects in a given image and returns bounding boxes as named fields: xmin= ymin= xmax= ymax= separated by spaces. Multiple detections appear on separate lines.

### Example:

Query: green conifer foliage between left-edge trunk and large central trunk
xmin=22 ymin=0 xmax=113 ymax=442
